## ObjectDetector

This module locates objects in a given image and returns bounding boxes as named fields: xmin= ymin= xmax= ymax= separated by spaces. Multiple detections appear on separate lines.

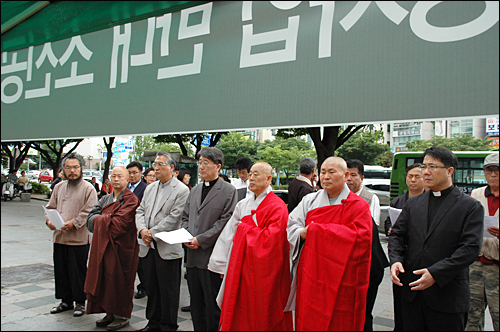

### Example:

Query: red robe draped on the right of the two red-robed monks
xmin=295 ymin=192 xmax=373 ymax=331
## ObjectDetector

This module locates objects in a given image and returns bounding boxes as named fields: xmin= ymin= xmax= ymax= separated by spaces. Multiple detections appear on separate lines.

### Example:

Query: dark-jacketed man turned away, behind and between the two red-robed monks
xmin=288 ymin=158 xmax=316 ymax=212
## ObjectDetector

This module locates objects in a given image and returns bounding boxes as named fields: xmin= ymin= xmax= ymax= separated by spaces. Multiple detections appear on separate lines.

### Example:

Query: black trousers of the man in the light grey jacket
xmin=143 ymin=243 xmax=182 ymax=331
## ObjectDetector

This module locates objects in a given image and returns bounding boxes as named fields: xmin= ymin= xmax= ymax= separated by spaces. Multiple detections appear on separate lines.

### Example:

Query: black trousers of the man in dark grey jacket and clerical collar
xmin=186 ymin=267 xmax=222 ymax=331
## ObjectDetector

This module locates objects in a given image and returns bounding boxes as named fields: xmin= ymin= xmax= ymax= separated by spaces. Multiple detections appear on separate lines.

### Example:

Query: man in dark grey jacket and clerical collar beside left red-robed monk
xmin=182 ymin=147 xmax=238 ymax=331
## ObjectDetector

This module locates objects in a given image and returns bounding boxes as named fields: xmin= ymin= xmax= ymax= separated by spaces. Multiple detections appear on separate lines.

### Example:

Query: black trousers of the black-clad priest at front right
xmin=401 ymin=291 xmax=468 ymax=331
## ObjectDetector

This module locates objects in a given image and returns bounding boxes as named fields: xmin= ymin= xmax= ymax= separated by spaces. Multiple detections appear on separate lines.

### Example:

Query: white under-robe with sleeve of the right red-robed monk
xmin=285 ymin=184 xmax=350 ymax=311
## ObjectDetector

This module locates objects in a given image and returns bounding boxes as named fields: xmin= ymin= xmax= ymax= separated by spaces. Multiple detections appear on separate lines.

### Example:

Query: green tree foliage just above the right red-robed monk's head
xmin=335 ymin=130 xmax=392 ymax=165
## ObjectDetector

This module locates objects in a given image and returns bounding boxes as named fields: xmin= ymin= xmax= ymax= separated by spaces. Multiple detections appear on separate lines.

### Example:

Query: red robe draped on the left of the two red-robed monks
xmin=219 ymin=192 xmax=293 ymax=331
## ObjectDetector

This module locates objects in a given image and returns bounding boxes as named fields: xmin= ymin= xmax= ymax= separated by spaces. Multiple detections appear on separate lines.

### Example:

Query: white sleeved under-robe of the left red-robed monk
xmin=208 ymin=186 xmax=272 ymax=308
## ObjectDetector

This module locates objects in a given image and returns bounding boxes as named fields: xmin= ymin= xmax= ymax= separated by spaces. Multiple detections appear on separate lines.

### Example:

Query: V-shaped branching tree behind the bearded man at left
xmin=26 ymin=138 xmax=83 ymax=175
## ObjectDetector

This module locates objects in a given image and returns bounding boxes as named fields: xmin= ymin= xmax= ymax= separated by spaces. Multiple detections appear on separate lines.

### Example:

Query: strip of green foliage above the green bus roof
xmin=406 ymin=134 xmax=491 ymax=151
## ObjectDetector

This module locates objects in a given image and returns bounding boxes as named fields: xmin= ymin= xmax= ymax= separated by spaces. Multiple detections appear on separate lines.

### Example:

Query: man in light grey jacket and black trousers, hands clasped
xmin=135 ymin=152 xmax=189 ymax=331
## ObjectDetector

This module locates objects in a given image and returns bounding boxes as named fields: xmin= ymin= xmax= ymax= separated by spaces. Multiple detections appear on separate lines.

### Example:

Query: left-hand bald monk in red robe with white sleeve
xmin=208 ymin=162 xmax=293 ymax=331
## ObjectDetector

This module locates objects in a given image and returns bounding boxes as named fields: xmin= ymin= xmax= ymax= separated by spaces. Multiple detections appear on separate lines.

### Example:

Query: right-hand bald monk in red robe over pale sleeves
xmin=286 ymin=157 xmax=373 ymax=331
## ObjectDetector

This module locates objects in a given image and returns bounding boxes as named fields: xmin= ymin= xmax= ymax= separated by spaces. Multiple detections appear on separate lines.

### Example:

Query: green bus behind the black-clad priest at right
xmin=391 ymin=150 xmax=498 ymax=201
